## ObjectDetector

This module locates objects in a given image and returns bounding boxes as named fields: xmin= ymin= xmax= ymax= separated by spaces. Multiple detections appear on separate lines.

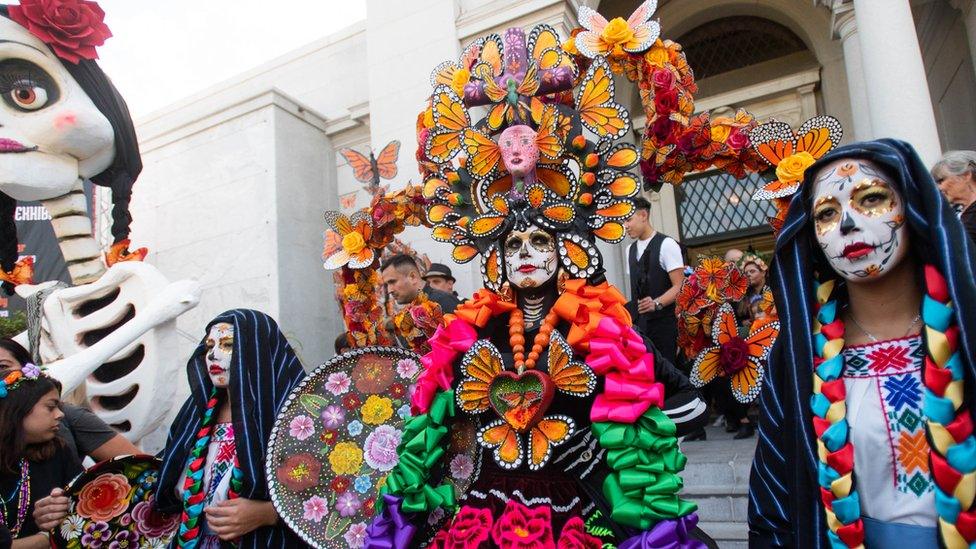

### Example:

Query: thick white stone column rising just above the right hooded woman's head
xmin=854 ymin=0 xmax=942 ymax=165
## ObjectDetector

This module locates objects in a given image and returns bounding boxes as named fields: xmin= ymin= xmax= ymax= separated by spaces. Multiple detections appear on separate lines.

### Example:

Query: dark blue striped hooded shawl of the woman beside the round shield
xmin=156 ymin=309 xmax=305 ymax=549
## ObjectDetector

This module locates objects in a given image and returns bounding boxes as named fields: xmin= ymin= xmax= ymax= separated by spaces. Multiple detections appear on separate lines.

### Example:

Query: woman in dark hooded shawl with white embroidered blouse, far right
xmin=749 ymin=139 xmax=976 ymax=548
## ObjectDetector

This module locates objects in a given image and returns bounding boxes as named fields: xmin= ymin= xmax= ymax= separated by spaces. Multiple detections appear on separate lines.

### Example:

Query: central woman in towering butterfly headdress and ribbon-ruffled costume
xmin=364 ymin=25 xmax=707 ymax=548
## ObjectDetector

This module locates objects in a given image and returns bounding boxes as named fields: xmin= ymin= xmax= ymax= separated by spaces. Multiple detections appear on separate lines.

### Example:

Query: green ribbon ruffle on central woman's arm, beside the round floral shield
xmin=376 ymin=391 xmax=457 ymax=513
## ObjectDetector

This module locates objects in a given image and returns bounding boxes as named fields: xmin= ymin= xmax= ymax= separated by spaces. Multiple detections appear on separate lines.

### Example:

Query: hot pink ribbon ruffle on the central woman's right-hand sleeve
xmin=586 ymin=317 xmax=664 ymax=423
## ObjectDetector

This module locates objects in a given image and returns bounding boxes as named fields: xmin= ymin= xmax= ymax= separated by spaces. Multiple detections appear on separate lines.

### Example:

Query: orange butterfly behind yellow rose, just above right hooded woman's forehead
xmin=749 ymin=115 xmax=844 ymax=200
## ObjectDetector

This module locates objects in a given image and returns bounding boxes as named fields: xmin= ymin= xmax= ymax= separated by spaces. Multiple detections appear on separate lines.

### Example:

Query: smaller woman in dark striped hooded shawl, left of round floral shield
xmin=156 ymin=309 xmax=306 ymax=549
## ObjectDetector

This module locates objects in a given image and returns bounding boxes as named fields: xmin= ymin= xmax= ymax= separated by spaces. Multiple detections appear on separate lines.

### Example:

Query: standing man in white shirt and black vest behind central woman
xmin=624 ymin=197 xmax=685 ymax=364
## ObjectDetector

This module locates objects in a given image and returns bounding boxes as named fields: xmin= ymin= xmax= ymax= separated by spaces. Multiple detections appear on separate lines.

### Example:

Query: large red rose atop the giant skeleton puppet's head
xmin=7 ymin=0 xmax=112 ymax=64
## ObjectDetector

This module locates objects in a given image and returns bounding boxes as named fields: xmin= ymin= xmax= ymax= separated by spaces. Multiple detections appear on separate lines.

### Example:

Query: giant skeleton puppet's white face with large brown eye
xmin=0 ymin=17 xmax=115 ymax=200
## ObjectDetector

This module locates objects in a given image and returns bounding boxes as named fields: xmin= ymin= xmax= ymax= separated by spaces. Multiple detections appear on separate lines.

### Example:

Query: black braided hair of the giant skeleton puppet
xmin=0 ymin=5 xmax=142 ymax=294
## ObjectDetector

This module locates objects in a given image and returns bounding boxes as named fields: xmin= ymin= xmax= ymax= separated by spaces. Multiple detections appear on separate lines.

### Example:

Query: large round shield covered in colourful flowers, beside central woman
xmin=267 ymin=347 xmax=477 ymax=549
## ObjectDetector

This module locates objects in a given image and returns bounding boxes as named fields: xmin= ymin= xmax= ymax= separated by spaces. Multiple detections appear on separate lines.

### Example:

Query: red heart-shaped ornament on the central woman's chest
xmin=488 ymin=370 xmax=556 ymax=433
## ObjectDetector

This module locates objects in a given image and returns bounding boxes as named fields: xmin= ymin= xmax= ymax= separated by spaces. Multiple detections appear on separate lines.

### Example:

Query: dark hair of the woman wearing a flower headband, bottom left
xmin=0 ymin=369 xmax=64 ymax=474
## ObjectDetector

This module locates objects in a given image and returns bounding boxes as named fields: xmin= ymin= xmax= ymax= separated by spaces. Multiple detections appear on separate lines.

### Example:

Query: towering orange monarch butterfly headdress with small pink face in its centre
xmin=417 ymin=25 xmax=639 ymax=290
